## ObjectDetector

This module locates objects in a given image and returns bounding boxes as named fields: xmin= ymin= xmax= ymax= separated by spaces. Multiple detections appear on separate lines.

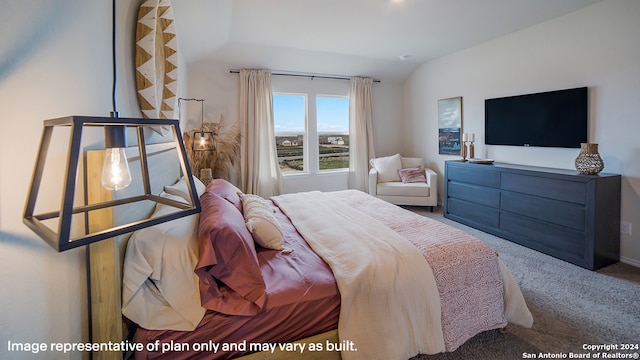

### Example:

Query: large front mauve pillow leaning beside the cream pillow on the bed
xmin=195 ymin=192 xmax=266 ymax=316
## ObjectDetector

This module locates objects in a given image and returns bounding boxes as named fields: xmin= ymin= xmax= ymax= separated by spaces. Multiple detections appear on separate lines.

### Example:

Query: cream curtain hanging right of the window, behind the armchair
xmin=349 ymin=77 xmax=375 ymax=191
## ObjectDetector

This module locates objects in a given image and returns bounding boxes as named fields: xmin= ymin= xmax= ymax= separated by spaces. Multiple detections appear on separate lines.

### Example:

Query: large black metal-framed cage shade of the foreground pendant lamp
xmin=23 ymin=116 xmax=201 ymax=251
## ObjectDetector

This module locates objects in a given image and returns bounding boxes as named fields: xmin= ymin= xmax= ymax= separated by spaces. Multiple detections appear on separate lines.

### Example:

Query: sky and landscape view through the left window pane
xmin=273 ymin=94 xmax=306 ymax=173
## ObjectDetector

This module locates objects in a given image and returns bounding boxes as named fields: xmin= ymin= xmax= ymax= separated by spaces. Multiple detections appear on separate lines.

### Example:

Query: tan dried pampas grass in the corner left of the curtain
xmin=183 ymin=115 xmax=240 ymax=183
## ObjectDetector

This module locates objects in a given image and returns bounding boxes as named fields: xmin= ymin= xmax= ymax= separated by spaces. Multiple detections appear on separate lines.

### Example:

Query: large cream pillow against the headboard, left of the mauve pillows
xmin=122 ymin=192 xmax=205 ymax=331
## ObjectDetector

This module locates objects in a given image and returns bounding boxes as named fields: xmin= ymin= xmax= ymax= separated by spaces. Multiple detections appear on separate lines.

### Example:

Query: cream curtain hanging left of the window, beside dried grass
xmin=240 ymin=70 xmax=282 ymax=198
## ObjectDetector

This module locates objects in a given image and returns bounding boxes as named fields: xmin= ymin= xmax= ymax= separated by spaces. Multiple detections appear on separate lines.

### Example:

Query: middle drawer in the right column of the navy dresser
xmin=500 ymin=191 xmax=585 ymax=231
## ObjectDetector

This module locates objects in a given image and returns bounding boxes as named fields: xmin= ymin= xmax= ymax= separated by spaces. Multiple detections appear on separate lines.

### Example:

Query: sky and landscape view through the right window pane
xmin=316 ymin=96 xmax=349 ymax=171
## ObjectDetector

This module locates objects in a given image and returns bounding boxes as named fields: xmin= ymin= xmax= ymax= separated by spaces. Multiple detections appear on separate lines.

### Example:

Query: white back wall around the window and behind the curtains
xmin=181 ymin=58 xmax=403 ymax=193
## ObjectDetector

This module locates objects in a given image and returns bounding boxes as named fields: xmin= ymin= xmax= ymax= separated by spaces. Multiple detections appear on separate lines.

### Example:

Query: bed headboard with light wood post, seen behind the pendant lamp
xmin=85 ymin=142 xmax=182 ymax=359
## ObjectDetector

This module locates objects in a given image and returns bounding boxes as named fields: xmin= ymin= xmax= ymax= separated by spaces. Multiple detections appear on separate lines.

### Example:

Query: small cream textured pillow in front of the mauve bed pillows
xmin=242 ymin=194 xmax=284 ymax=250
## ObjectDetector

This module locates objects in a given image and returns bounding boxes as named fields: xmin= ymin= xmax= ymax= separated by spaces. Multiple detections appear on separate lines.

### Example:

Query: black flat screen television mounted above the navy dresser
xmin=484 ymin=87 xmax=589 ymax=148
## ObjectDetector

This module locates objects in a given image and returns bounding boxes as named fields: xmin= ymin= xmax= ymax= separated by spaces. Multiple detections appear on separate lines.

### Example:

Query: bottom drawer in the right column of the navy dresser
xmin=500 ymin=213 xmax=586 ymax=258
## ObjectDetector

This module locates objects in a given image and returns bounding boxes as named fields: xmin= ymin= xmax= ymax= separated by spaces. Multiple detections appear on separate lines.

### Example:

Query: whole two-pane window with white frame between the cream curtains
xmin=273 ymin=93 xmax=349 ymax=175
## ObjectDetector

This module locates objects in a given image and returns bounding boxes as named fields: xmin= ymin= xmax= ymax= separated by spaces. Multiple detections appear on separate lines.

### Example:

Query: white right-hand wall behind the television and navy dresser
xmin=404 ymin=0 xmax=640 ymax=266
